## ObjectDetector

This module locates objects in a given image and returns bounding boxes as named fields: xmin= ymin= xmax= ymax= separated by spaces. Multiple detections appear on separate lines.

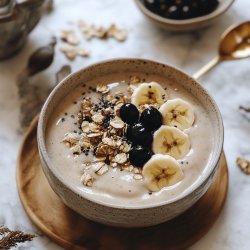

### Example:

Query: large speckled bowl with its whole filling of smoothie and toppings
xmin=38 ymin=59 xmax=223 ymax=227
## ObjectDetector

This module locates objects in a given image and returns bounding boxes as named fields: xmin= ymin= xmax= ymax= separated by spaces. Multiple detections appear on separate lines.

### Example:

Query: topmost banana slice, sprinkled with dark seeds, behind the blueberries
xmin=131 ymin=82 xmax=167 ymax=107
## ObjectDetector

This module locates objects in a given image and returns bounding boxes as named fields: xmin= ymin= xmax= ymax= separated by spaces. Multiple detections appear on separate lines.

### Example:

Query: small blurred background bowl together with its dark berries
xmin=135 ymin=0 xmax=234 ymax=31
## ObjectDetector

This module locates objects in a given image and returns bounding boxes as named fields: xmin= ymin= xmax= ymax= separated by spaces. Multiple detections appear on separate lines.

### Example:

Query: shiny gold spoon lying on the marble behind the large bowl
xmin=193 ymin=21 xmax=250 ymax=79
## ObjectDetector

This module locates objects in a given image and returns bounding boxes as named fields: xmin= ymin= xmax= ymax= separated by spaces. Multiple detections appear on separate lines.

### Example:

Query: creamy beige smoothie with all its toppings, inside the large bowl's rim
xmin=46 ymin=75 xmax=214 ymax=207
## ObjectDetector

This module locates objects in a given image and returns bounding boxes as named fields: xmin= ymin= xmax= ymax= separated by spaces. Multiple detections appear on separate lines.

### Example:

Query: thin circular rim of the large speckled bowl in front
xmin=37 ymin=58 xmax=224 ymax=210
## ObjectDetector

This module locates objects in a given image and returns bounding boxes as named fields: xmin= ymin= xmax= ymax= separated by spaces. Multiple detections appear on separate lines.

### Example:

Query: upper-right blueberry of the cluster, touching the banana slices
xmin=140 ymin=107 xmax=163 ymax=131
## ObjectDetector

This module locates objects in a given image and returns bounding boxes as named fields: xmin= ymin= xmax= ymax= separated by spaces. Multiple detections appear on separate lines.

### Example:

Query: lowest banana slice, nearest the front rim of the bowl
xmin=142 ymin=154 xmax=184 ymax=191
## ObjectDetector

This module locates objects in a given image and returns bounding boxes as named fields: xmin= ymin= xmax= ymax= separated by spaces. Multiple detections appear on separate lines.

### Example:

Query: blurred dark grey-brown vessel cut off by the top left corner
xmin=0 ymin=0 xmax=44 ymax=60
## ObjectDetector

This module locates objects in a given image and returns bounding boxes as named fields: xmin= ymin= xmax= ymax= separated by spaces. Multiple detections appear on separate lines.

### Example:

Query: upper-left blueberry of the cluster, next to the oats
xmin=120 ymin=103 xmax=140 ymax=125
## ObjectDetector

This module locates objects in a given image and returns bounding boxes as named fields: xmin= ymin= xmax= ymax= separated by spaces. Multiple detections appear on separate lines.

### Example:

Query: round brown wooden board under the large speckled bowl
xmin=17 ymin=117 xmax=228 ymax=250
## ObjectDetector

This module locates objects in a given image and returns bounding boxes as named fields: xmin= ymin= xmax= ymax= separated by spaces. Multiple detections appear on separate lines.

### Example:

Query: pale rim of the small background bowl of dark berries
xmin=135 ymin=0 xmax=235 ymax=27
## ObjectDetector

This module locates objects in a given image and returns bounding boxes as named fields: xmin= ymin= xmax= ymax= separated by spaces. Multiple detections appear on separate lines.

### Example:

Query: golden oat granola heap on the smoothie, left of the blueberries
xmin=63 ymin=79 xmax=143 ymax=186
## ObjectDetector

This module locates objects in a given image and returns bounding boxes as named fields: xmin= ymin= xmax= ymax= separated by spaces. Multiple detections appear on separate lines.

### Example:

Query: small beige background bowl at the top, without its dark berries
xmin=135 ymin=0 xmax=234 ymax=31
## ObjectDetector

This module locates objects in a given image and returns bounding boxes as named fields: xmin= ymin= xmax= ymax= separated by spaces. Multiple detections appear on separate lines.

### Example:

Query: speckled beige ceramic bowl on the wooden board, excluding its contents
xmin=38 ymin=59 xmax=223 ymax=227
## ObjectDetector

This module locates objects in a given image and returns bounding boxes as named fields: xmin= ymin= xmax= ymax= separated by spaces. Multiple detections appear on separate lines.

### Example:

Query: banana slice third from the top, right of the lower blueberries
xmin=153 ymin=126 xmax=190 ymax=160
